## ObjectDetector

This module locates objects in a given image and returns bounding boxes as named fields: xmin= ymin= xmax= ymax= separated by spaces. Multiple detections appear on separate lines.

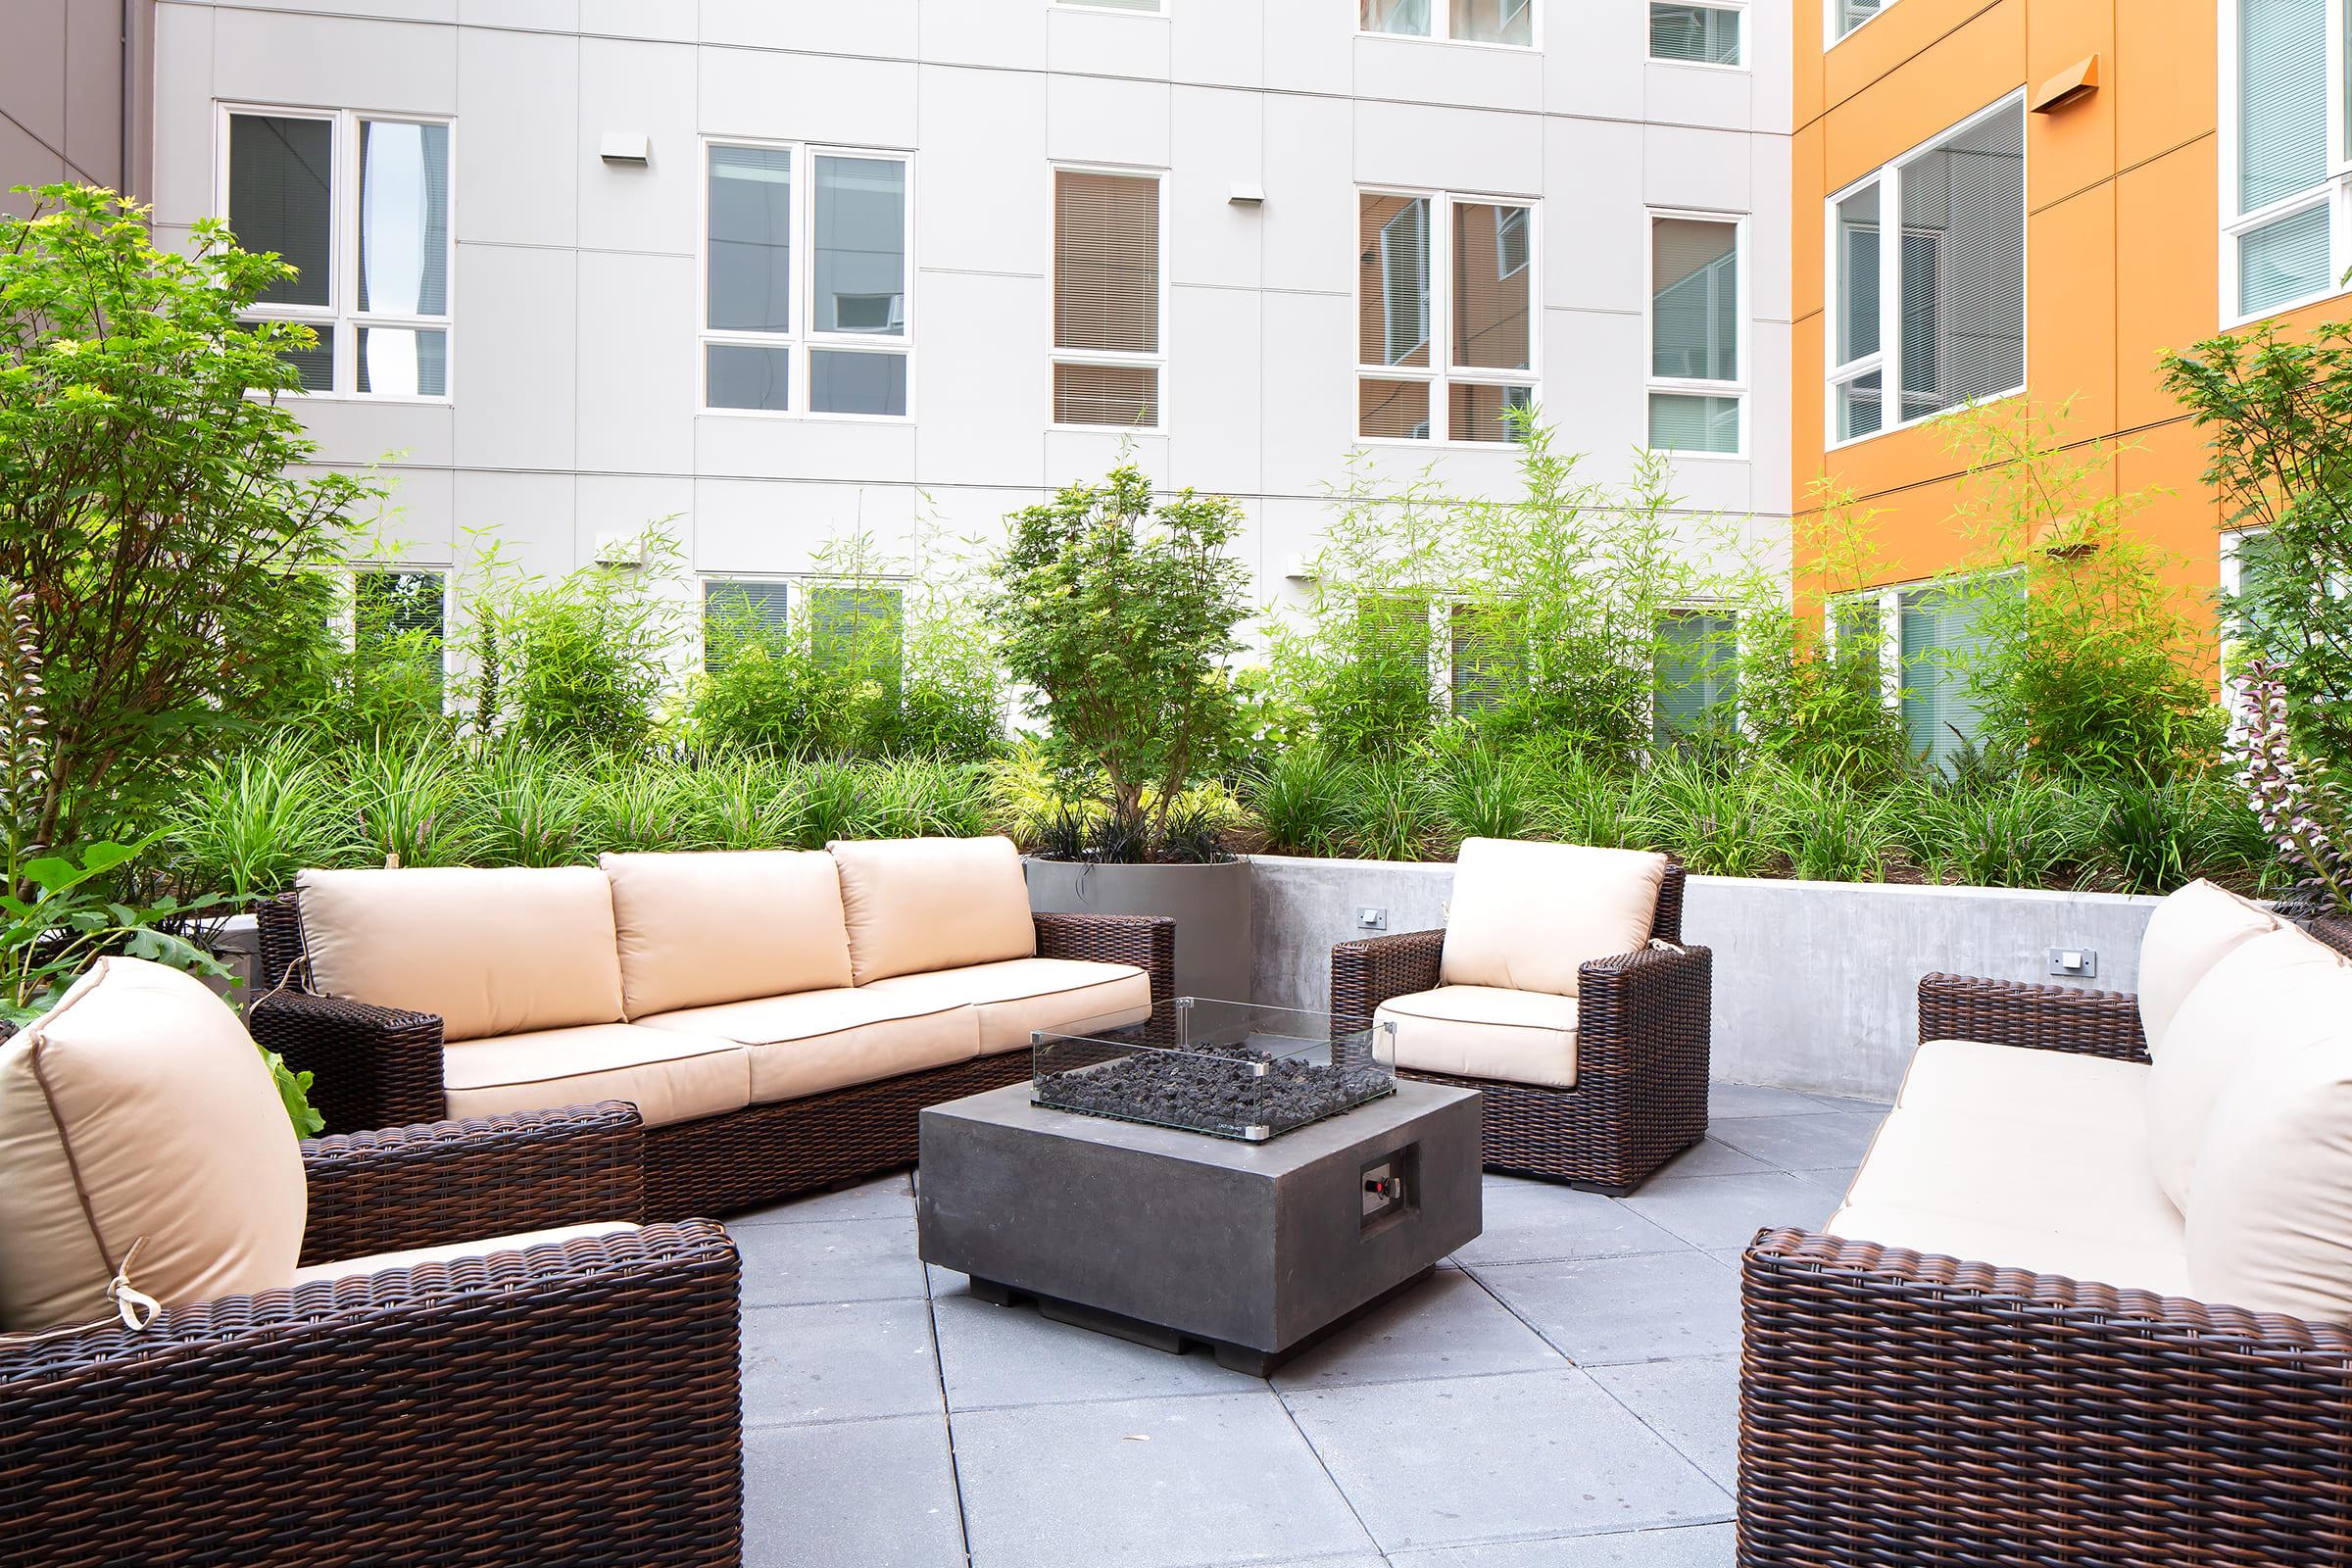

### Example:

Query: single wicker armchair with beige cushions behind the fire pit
xmin=1331 ymin=839 xmax=1715 ymax=1192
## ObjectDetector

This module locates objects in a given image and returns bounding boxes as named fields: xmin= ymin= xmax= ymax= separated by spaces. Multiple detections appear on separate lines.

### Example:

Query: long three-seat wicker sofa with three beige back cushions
xmin=249 ymin=839 xmax=1174 ymax=1220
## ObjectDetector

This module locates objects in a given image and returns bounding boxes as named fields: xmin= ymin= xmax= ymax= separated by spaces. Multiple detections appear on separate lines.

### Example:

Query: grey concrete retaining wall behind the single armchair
xmin=1251 ymin=856 xmax=2157 ymax=1101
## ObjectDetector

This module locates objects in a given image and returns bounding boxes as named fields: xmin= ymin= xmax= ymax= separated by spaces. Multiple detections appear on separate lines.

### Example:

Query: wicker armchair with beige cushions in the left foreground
xmin=0 ymin=959 xmax=743 ymax=1568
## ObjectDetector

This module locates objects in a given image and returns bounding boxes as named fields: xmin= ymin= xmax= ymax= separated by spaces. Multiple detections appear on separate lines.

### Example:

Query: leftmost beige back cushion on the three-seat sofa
xmin=296 ymin=865 xmax=621 ymax=1039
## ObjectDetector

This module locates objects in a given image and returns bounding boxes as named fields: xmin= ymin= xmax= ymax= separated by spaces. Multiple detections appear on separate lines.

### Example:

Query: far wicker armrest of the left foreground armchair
xmin=301 ymin=1101 xmax=645 ymax=1262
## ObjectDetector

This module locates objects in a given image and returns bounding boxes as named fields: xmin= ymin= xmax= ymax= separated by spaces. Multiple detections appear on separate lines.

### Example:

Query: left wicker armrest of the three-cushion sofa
xmin=245 ymin=990 xmax=449 ymax=1133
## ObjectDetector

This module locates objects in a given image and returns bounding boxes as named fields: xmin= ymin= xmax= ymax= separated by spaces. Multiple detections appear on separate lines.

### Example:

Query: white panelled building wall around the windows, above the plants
xmin=155 ymin=0 xmax=1792 ymax=625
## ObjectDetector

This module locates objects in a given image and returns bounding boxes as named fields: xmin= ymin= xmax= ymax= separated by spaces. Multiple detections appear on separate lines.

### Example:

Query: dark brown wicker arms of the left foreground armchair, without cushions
xmin=0 ymin=1104 xmax=743 ymax=1568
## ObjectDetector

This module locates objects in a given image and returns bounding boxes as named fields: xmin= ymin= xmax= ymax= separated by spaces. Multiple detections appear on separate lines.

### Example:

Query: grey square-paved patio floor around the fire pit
xmin=729 ymin=1084 xmax=1884 ymax=1568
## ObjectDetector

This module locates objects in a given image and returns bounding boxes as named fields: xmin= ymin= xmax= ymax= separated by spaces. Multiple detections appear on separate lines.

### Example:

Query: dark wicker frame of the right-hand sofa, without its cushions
xmin=1739 ymin=906 xmax=2352 ymax=1568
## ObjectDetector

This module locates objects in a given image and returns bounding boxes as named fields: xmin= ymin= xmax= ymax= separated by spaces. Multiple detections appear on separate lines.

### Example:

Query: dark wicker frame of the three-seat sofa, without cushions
xmin=247 ymin=898 xmax=1176 ymax=1230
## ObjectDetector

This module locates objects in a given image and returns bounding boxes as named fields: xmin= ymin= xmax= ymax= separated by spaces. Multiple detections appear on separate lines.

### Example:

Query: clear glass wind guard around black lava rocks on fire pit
xmin=1030 ymin=997 xmax=1397 ymax=1143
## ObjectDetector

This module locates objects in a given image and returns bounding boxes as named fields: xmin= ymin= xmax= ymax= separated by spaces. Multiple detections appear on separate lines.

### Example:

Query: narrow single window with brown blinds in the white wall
xmin=1052 ymin=167 xmax=1166 ymax=430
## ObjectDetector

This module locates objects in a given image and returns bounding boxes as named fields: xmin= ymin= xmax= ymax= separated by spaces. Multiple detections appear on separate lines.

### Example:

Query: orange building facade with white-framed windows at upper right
xmin=1792 ymin=0 xmax=2352 ymax=750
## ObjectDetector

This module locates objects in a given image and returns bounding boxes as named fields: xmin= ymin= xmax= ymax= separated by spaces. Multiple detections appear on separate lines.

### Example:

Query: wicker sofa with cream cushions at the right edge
xmin=1739 ymin=889 xmax=2352 ymax=1568
